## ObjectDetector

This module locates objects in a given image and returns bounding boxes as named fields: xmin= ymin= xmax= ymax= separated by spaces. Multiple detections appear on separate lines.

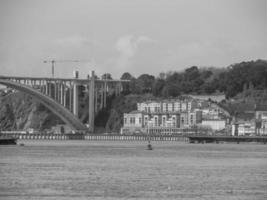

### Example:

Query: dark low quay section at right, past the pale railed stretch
xmin=188 ymin=136 xmax=267 ymax=144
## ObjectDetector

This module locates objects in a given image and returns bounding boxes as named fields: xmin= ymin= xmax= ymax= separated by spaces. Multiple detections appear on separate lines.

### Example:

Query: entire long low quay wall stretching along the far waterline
xmin=0 ymin=133 xmax=267 ymax=144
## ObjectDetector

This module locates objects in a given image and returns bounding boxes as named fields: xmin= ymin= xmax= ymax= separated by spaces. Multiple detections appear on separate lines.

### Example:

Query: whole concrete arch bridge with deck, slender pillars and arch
xmin=0 ymin=71 xmax=128 ymax=132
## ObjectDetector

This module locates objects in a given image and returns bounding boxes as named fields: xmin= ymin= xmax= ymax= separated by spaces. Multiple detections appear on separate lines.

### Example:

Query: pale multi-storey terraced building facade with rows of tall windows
xmin=121 ymin=100 xmax=202 ymax=133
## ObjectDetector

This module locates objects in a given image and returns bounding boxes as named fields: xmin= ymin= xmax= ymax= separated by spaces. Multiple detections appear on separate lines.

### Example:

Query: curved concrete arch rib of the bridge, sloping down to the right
xmin=0 ymin=79 xmax=87 ymax=131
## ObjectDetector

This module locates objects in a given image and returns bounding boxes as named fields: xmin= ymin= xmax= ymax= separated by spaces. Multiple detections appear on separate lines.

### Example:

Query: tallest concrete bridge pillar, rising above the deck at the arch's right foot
xmin=88 ymin=71 xmax=95 ymax=132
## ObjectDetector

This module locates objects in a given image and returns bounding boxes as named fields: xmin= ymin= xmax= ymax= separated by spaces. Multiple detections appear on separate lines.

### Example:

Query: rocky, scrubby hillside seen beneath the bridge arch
xmin=0 ymin=92 xmax=62 ymax=130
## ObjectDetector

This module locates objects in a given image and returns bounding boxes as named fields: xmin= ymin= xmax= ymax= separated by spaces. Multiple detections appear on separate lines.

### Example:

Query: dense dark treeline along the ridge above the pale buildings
xmin=121 ymin=60 xmax=267 ymax=98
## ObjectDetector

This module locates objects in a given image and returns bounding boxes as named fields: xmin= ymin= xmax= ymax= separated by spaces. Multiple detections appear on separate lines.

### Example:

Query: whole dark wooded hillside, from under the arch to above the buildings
xmin=0 ymin=60 xmax=267 ymax=132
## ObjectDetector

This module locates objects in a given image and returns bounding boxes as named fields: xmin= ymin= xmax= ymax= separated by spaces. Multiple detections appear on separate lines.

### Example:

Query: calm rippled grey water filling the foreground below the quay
xmin=0 ymin=141 xmax=267 ymax=200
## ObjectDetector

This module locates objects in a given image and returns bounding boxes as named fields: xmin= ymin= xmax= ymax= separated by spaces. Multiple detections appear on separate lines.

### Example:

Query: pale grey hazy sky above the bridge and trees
xmin=0 ymin=0 xmax=267 ymax=78
